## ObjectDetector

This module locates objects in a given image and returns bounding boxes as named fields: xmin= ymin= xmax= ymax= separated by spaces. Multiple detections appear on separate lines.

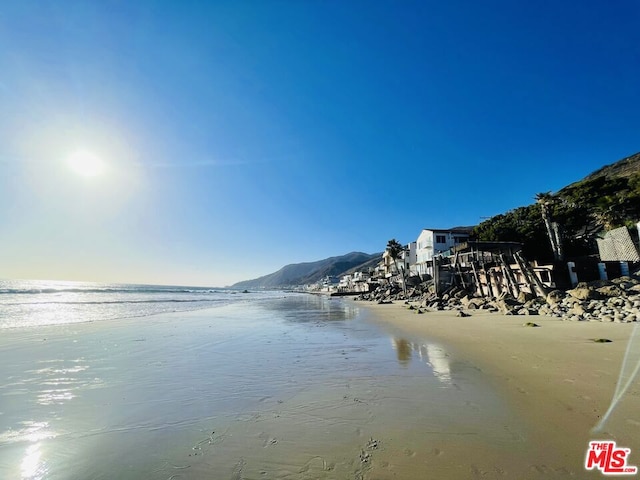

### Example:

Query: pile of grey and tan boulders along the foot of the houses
xmin=356 ymin=276 xmax=640 ymax=323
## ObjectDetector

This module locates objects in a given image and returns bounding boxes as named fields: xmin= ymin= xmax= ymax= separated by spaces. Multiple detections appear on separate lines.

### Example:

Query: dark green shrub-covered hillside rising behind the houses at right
xmin=473 ymin=153 xmax=640 ymax=259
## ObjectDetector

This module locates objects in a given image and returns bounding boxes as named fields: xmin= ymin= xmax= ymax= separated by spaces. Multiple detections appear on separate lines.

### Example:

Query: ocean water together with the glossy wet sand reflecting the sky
xmin=0 ymin=282 xmax=521 ymax=480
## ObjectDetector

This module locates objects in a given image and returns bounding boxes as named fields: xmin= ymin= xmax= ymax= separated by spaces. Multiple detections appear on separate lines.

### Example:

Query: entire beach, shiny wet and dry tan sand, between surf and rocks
xmin=0 ymin=295 xmax=640 ymax=480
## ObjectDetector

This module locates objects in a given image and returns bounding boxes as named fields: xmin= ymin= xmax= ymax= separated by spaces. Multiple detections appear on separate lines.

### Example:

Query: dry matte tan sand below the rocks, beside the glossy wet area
xmin=356 ymin=302 xmax=640 ymax=479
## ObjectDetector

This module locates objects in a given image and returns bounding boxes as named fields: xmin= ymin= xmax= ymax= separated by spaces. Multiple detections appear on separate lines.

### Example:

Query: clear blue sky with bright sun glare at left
xmin=0 ymin=0 xmax=640 ymax=286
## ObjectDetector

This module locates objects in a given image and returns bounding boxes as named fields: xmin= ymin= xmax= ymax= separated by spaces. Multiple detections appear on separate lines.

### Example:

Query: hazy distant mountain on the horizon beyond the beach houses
xmin=231 ymin=252 xmax=382 ymax=288
